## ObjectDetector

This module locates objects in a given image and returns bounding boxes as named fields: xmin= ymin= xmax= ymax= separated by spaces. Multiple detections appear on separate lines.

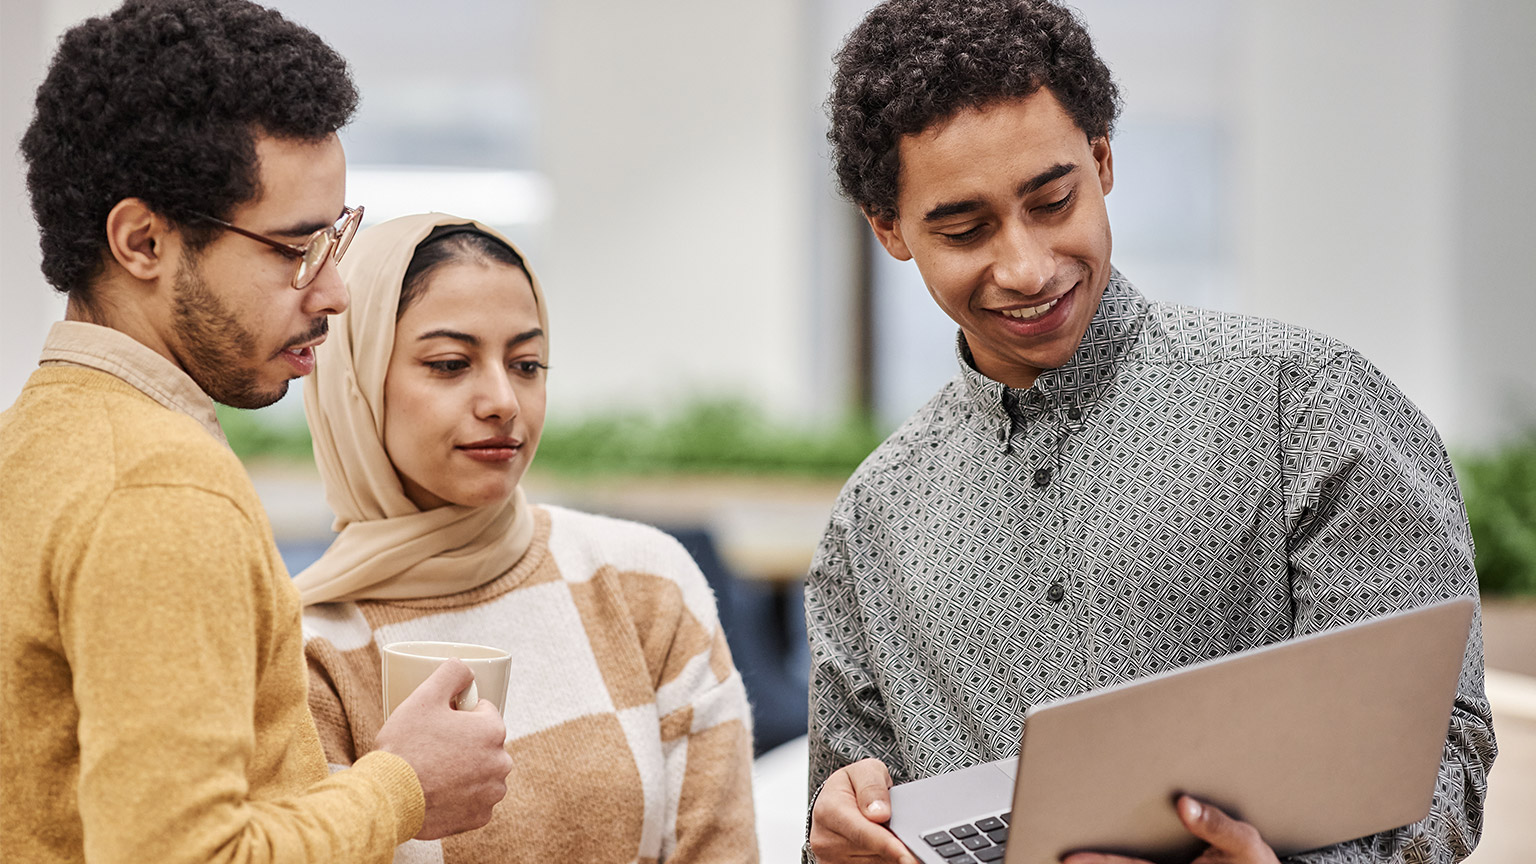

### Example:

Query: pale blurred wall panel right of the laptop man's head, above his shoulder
xmin=1233 ymin=0 xmax=1449 ymax=437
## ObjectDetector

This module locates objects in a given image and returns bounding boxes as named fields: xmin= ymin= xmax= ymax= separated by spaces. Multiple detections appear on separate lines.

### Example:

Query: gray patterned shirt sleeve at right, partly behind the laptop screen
xmin=1283 ymin=352 xmax=1496 ymax=864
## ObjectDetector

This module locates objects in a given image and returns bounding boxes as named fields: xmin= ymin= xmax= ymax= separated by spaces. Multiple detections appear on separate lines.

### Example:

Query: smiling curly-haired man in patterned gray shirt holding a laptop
xmin=806 ymin=0 xmax=1495 ymax=864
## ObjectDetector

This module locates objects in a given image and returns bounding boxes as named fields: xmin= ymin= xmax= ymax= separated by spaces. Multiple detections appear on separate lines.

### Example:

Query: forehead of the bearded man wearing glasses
xmin=232 ymin=134 xmax=347 ymax=231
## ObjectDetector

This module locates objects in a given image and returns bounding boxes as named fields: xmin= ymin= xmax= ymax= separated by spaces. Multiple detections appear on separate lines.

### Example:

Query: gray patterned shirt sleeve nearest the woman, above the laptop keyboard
xmin=805 ymin=504 xmax=908 ymax=805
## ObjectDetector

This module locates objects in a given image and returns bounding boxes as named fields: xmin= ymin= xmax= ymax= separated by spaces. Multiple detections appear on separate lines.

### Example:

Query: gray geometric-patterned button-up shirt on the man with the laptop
xmin=806 ymin=272 xmax=1496 ymax=861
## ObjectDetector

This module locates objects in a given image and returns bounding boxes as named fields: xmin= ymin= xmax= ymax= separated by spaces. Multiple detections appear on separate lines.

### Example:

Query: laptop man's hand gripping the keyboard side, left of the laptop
xmin=809 ymin=759 xmax=919 ymax=864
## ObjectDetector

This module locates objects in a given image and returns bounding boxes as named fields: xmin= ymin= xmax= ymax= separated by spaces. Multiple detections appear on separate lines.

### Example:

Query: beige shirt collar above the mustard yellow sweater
xmin=38 ymin=321 xmax=229 ymax=446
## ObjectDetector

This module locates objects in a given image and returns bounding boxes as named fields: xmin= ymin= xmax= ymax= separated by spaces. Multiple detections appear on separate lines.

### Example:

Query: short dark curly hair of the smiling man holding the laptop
xmin=826 ymin=0 xmax=1120 ymax=218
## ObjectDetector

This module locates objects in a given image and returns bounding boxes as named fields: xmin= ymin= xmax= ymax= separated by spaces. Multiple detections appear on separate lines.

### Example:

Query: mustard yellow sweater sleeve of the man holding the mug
xmin=55 ymin=486 xmax=422 ymax=864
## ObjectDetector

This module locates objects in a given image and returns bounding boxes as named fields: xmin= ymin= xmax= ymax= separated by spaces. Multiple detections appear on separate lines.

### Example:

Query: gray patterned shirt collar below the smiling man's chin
xmin=955 ymin=268 xmax=1147 ymax=418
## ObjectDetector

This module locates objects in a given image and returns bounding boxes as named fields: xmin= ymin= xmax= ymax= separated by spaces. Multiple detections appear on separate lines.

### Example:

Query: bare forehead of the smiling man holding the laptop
xmin=897 ymin=88 xmax=1092 ymax=215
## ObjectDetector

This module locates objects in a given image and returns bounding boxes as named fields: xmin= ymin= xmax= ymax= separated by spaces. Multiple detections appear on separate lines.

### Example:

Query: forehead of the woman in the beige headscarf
xmin=399 ymin=261 xmax=539 ymax=328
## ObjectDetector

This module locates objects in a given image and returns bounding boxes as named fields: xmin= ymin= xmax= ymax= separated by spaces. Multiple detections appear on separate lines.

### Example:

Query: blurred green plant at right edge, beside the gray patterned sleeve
xmin=1455 ymin=432 xmax=1536 ymax=593
